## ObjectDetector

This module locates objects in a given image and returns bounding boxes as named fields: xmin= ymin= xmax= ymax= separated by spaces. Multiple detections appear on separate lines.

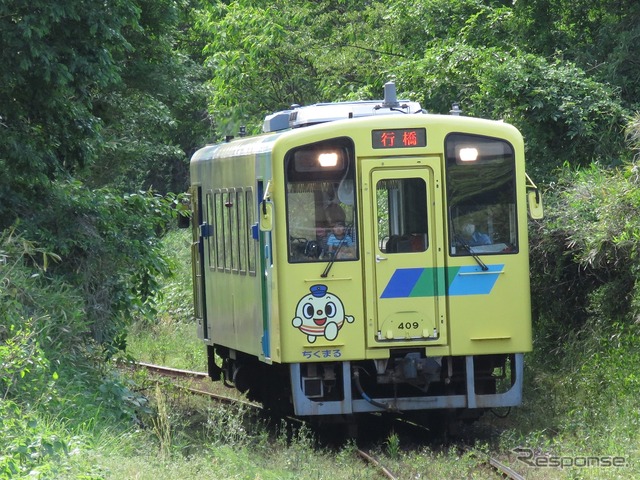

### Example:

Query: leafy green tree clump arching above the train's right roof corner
xmin=397 ymin=44 xmax=628 ymax=180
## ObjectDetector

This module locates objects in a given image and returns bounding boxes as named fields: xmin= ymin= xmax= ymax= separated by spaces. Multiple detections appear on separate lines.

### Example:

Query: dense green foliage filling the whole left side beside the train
xmin=0 ymin=0 xmax=205 ymax=478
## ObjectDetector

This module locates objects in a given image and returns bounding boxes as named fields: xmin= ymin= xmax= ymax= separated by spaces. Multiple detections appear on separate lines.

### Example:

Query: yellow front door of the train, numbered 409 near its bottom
xmin=362 ymin=157 xmax=446 ymax=347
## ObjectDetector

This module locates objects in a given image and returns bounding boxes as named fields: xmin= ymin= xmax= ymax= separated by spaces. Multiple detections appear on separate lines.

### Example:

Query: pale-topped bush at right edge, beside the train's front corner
xmin=531 ymin=159 xmax=640 ymax=346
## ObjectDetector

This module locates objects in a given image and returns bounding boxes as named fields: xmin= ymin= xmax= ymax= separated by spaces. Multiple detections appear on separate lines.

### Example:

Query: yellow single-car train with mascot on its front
xmin=191 ymin=82 xmax=542 ymax=417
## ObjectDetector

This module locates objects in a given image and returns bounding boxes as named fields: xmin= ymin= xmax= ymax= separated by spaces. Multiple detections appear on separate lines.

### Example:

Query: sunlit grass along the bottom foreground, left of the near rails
xmin=56 ymin=388 xmax=390 ymax=480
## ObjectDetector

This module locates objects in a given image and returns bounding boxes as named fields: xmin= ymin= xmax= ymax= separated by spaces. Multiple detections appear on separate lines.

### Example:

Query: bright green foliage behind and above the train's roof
xmin=198 ymin=0 xmax=637 ymax=180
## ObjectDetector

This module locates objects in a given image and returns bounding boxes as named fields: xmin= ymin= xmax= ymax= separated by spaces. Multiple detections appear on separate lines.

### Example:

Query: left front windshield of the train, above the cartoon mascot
xmin=285 ymin=138 xmax=358 ymax=263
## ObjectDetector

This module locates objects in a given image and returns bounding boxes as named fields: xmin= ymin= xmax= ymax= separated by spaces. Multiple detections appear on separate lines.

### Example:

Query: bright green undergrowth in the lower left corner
xmin=0 ymin=219 xmax=157 ymax=478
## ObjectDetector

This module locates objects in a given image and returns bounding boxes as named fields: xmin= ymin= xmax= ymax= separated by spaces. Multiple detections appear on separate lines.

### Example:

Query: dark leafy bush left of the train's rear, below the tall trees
xmin=16 ymin=182 xmax=185 ymax=356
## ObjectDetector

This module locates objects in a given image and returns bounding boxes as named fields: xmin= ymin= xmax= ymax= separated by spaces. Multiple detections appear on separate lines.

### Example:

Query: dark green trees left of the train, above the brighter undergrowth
xmin=0 ymin=0 xmax=208 ymax=347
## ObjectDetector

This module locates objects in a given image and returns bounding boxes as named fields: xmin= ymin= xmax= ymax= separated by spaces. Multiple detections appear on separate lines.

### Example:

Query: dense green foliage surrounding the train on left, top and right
xmin=0 ymin=0 xmax=640 ymax=477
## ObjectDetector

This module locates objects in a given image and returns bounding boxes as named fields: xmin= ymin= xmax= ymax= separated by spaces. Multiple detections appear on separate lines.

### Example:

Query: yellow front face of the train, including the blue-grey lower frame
xmin=271 ymin=115 xmax=531 ymax=415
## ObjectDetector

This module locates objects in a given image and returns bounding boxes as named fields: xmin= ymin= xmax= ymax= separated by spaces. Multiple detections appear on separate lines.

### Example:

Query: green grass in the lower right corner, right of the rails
xmin=488 ymin=335 xmax=640 ymax=479
